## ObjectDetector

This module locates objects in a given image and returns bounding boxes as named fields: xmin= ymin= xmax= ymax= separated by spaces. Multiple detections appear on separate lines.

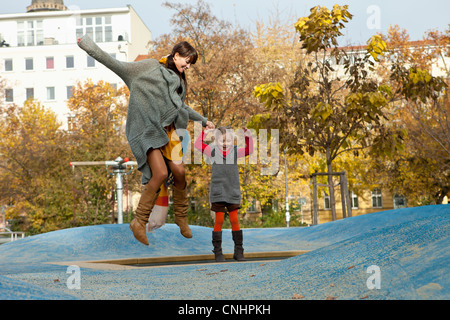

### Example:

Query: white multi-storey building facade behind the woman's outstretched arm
xmin=0 ymin=0 xmax=152 ymax=129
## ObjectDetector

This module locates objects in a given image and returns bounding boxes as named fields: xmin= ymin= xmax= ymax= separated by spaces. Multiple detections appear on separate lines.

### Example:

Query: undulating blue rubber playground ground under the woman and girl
xmin=0 ymin=205 xmax=450 ymax=300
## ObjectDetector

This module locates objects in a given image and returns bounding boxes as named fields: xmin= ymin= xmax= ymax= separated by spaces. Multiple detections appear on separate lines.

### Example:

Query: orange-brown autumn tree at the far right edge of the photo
xmin=374 ymin=25 xmax=450 ymax=205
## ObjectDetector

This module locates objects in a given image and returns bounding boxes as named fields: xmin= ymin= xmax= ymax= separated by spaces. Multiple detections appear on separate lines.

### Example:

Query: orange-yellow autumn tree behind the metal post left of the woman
xmin=67 ymin=80 xmax=139 ymax=225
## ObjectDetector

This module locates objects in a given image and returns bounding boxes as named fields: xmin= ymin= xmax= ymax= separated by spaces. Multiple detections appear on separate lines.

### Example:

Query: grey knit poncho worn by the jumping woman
xmin=78 ymin=35 xmax=207 ymax=184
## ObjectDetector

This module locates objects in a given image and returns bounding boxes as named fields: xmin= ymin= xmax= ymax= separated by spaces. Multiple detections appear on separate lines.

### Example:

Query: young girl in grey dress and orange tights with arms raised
xmin=194 ymin=127 xmax=253 ymax=262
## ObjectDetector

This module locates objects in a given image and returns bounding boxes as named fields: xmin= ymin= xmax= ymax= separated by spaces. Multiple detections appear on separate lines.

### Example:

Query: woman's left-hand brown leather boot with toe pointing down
xmin=130 ymin=185 xmax=159 ymax=246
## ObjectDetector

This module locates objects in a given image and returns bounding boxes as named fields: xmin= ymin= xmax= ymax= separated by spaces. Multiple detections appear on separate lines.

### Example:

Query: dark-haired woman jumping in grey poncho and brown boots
xmin=78 ymin=35 xmax=214 ymax=245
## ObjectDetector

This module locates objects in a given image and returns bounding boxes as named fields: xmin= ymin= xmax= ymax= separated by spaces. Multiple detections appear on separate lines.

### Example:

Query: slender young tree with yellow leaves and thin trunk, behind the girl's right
xmin=254 ymin=5 xmax=403 ymax=219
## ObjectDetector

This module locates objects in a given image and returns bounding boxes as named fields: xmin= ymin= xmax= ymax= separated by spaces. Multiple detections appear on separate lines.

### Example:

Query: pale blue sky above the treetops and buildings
xmin=4 ymin=0 xmax=450 ymax=45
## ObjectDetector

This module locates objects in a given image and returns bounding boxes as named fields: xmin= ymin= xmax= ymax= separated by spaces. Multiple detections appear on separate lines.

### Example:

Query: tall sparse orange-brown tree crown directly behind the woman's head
xmin=149 ymin=0 xmax=259 ymax=128
